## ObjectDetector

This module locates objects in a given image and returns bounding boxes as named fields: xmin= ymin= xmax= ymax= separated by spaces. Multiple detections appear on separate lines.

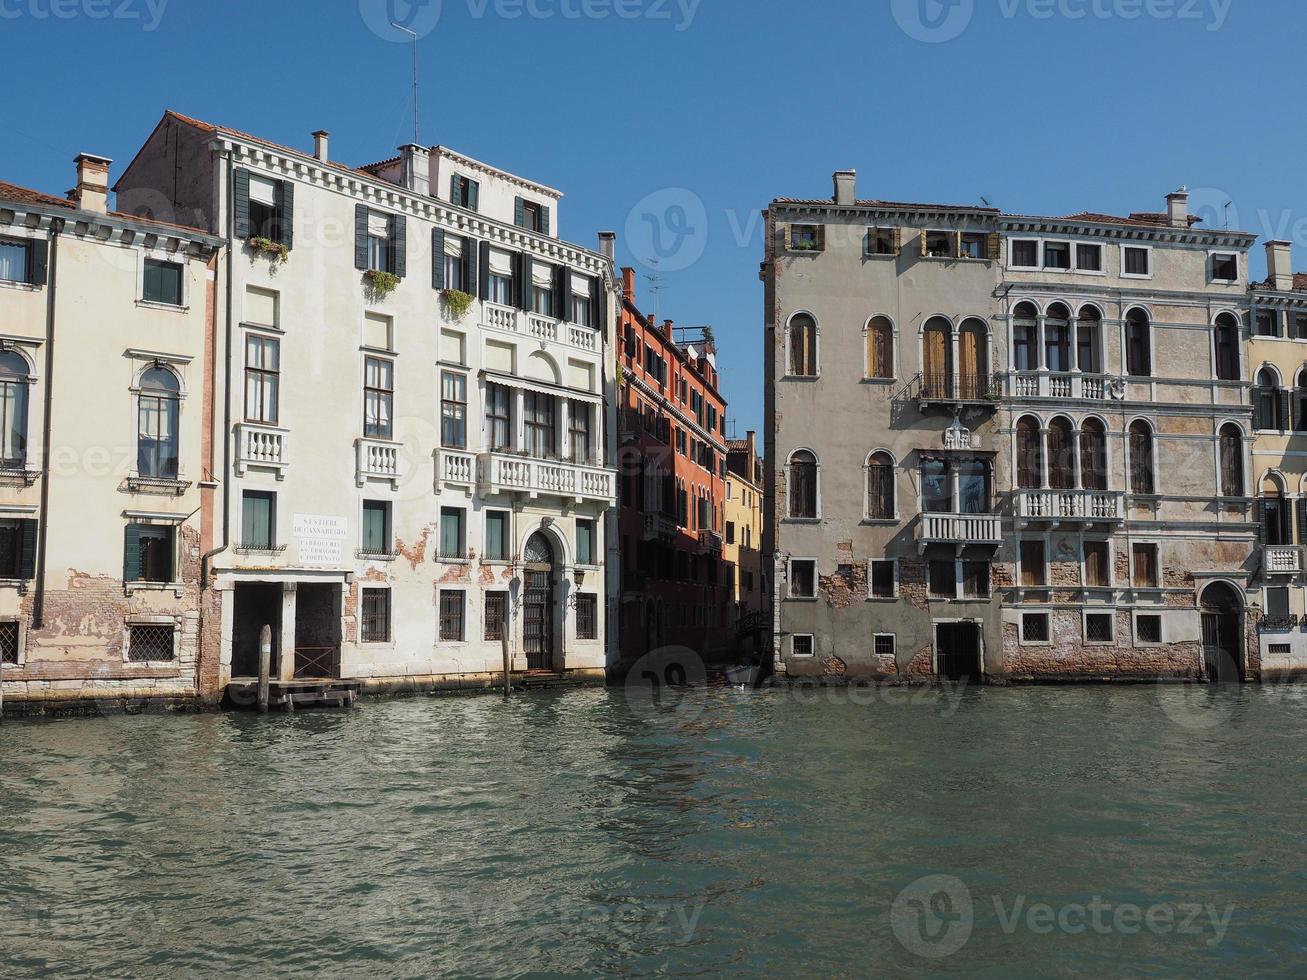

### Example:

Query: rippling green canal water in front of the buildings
xmin=0 ymin=687 xmax=1307 ymax=977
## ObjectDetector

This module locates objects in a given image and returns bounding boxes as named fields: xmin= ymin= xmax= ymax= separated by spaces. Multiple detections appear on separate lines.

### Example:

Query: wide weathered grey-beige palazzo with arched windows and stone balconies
xmin=763 ymin=171 xmax=1260 ymax=681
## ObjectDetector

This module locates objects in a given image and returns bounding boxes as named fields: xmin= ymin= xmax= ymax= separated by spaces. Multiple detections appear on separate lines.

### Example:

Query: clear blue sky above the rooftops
xmin=0 ymin=0 xmax=1307 ymax=434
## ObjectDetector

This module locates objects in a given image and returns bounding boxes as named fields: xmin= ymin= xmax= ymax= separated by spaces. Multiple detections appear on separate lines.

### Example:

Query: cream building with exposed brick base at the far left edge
xmin=0 ymin=154 xmax=220 ymax=710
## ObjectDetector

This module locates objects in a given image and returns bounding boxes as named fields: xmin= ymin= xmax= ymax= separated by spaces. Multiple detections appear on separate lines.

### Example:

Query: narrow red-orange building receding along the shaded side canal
xmin=618 ymin=269 xmax=735 ymax=662
